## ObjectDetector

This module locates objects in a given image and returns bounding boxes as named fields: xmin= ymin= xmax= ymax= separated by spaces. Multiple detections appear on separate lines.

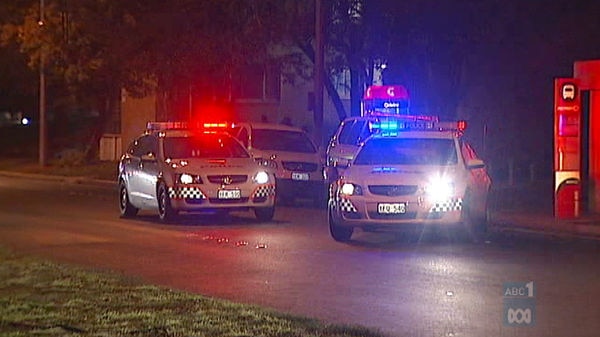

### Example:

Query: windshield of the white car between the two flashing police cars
xmin=252 ymin=129 xmax=317 ymax=153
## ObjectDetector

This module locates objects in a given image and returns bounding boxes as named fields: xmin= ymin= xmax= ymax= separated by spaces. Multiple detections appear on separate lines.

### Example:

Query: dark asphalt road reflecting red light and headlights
xmin=0 ymin=177 xmax=600 ymax=337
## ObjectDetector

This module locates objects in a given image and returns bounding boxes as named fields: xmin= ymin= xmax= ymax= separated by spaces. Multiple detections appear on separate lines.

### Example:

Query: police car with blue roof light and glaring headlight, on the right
xmin=328 ymin=117 xmax=491 ymax=241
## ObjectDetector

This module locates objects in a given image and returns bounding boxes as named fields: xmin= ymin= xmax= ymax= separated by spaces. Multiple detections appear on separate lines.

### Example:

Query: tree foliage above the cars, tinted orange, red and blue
xmin=2 ymin=0 xmax=408 ymax=127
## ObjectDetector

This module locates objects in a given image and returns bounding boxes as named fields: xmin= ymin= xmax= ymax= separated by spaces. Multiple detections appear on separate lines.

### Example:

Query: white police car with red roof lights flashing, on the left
xmin=118 ymin=123 xmax=276 ymax=221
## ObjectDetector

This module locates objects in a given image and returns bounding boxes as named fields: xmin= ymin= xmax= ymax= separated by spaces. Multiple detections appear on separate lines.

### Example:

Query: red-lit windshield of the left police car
xmin=164 ymin=134 xmax=250 ymax=159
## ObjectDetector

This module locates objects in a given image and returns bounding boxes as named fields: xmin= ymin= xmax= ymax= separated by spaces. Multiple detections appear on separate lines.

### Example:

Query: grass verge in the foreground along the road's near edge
xmin=0 ymin=247 xmax=383 ymax=337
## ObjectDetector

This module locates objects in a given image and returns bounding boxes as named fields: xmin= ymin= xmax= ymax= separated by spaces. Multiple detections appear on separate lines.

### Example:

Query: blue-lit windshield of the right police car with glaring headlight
xmin=354 ymin=138 xmax=458 ymax=165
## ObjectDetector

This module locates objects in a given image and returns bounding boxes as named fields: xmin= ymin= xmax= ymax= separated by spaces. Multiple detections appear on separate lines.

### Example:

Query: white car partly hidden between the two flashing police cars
xmin=231 ymin=122 xmax=327 ymax=206
